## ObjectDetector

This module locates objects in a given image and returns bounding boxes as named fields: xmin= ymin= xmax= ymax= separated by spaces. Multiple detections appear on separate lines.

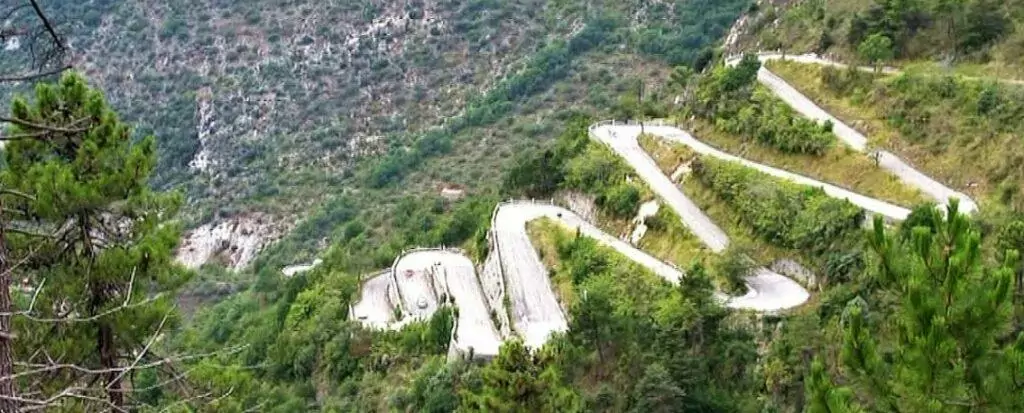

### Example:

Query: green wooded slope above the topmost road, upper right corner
xmin=730 ymin=0 xmax=1024 ymax=70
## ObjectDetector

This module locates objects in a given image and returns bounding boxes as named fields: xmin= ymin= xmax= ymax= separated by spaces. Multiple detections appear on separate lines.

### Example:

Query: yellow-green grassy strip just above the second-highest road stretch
xmin=686 ymin=115 xmax=927 ymax=206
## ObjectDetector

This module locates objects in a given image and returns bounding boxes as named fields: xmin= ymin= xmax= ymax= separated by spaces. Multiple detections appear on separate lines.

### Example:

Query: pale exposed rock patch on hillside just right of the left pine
xmin=177 ymin=214 xmax=284 ymax=270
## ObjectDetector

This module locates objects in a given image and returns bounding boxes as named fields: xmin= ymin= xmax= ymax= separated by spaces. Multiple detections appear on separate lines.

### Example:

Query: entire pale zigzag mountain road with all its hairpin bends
xmin=351 ymin=53 xmax=977 ymax=357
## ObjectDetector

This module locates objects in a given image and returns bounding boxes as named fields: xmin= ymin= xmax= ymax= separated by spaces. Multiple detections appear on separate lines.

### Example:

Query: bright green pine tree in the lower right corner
xmin=831 ymin=202 xmax=1024 ymax=412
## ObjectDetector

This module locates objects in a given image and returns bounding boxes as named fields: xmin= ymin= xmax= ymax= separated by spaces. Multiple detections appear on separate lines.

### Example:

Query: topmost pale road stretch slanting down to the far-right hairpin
xmin=726 ymin=53 xmax=978 ymax=213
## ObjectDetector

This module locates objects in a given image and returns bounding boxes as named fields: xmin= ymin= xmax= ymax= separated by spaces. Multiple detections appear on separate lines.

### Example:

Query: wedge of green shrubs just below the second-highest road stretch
xmin=693 ymin=158 xmax=864 ymax=255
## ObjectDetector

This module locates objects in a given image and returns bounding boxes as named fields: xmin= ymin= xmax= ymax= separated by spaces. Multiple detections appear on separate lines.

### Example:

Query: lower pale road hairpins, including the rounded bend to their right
xmin=352 ymin=201 xmax=809 ymax=356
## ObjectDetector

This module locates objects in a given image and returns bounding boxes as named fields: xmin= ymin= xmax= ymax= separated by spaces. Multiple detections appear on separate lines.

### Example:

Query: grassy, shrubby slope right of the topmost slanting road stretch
xmin=819 ymin=63 xmax=1024 ymax=210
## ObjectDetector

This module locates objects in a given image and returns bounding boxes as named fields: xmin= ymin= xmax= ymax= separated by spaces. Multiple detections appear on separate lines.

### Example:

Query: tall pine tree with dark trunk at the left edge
xmin=0 ymin=74 xmax=189 ymax=410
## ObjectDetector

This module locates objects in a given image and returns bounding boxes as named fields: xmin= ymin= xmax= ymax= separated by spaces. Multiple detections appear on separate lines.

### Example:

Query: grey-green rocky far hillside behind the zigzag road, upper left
xmin=6 ymin=1 xmax=741 ymax=274
